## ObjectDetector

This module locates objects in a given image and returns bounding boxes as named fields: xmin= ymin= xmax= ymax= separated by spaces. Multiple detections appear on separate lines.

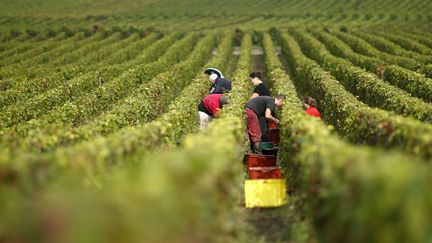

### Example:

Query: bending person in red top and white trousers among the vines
xmin=198 ymin=94 xmax=228 ymax=130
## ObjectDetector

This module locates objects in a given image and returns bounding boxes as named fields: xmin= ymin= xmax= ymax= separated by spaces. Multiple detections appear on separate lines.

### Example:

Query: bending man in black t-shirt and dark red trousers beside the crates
xmin=245 ymin=94 xmax=285 ymax=153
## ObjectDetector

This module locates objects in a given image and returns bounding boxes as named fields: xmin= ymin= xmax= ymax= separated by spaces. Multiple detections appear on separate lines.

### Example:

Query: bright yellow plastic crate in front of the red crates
xmin=244 ymin=179 xmax=287 ymax=208
